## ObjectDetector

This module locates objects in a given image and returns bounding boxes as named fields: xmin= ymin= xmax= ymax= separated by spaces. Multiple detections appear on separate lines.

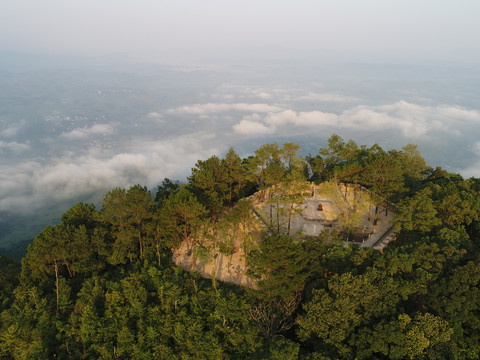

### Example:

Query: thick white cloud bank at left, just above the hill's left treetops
xmin=0 ymin=132 xmax=220 ymax=213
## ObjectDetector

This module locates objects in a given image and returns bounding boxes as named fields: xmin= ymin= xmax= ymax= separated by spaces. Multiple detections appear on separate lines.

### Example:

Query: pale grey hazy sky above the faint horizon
xmin=0 ymin=0 xmax=480 ymax=63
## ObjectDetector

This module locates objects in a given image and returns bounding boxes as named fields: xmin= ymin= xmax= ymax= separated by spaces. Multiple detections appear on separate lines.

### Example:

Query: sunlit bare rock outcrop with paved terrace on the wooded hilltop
xmin=173 ymin=182 xmax=395 ymax=287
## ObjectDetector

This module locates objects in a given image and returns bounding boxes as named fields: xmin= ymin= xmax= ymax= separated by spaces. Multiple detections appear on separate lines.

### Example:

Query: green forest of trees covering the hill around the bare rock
xmin=0 ymin=134 xmax=480 ymax=360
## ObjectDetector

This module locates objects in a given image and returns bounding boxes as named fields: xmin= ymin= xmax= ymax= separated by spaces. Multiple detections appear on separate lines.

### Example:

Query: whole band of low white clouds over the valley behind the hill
xmin=0 ymin=63 xmax=480 ymax=214
